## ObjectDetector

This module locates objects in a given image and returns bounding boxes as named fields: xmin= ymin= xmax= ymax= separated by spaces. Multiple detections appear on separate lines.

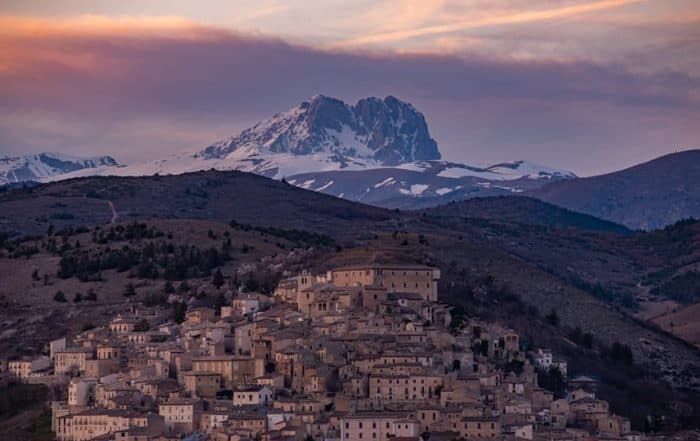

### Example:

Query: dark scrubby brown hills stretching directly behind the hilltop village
xmin=0 ymin=171 xmax=700 ymax=426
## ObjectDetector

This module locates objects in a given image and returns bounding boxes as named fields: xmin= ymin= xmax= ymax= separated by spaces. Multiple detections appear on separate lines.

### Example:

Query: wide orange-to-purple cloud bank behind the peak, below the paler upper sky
xmin=0 ymin=19 xmax=700 ymax=173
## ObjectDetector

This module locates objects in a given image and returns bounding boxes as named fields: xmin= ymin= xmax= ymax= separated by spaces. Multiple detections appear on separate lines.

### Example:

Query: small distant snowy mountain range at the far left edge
xmin=0 ymin=153 xmax=118 ymax=185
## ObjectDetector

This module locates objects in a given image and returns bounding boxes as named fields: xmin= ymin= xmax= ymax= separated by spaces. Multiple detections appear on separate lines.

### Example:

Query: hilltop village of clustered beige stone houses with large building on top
xmin=6 ymin=265 xmax=650 ymax=441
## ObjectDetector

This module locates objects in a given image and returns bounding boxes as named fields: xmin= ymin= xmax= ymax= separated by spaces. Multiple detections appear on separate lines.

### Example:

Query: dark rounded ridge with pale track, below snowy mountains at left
xmin=0 ymin=171 xmax=394 ymax=234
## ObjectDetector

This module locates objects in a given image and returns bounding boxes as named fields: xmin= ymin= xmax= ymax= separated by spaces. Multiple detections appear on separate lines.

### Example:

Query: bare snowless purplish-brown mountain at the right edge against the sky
xmin=530 ymin=150 xmax=700 ymax=230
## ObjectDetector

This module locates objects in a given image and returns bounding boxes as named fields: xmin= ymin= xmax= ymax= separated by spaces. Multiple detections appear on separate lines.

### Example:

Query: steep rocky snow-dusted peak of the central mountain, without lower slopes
xmin=198 ymin=95 xmax=440 ymax=168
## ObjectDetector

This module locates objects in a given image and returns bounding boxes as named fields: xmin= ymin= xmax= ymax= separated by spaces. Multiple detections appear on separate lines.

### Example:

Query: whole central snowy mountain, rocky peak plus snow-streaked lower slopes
xmin=35 ymin=95 xmax=575 ymax=208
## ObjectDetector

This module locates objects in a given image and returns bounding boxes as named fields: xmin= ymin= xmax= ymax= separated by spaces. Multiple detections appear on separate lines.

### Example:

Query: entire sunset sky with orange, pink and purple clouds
xmin=0 ymin=0 xmax=700 ymax=176
